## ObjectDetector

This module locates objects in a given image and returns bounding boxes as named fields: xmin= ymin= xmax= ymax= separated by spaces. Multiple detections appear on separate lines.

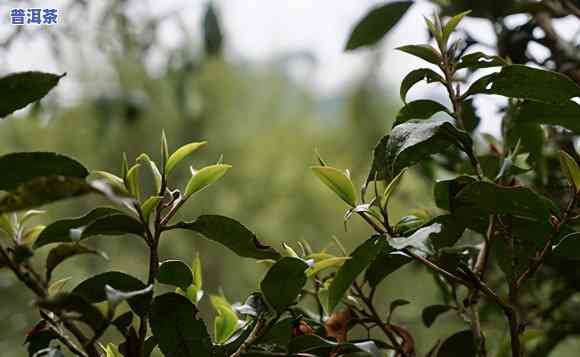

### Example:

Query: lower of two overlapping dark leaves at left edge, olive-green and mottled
xmin=0 ymin=176 xmax=98 ymax=214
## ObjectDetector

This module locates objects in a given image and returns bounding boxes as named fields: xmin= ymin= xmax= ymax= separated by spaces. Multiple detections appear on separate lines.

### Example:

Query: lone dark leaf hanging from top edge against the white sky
xmin=345 ymin=1 xmax=413 ymax=51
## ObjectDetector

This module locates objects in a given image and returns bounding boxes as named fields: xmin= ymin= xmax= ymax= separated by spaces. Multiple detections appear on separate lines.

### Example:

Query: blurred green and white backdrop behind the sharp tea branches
xmin=0 ymin=0 xmax=578 ymax=356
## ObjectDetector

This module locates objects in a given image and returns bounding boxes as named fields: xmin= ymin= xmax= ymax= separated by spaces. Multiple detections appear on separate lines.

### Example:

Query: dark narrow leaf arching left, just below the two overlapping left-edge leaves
xmin=33 ymin=207 xmax=121 ymax=249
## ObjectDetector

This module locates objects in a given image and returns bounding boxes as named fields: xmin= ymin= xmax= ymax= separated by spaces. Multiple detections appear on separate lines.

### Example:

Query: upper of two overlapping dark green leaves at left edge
xmin=0 ymin=152 xmax=89 ymax=191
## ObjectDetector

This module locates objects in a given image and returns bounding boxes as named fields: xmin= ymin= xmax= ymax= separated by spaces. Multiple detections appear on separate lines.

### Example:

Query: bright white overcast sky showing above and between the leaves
xmin=0 ymin=0 xmax=578 ymax=132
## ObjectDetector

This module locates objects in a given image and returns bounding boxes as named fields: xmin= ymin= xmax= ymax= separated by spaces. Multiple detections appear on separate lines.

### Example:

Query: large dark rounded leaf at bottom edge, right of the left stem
xmin=150 ymin=293 xmax=213 ymax=357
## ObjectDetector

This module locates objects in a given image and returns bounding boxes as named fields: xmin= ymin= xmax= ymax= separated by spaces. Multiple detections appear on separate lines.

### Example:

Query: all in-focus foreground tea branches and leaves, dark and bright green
xmin=0 ymin=1 xmax=580 ymax=357
